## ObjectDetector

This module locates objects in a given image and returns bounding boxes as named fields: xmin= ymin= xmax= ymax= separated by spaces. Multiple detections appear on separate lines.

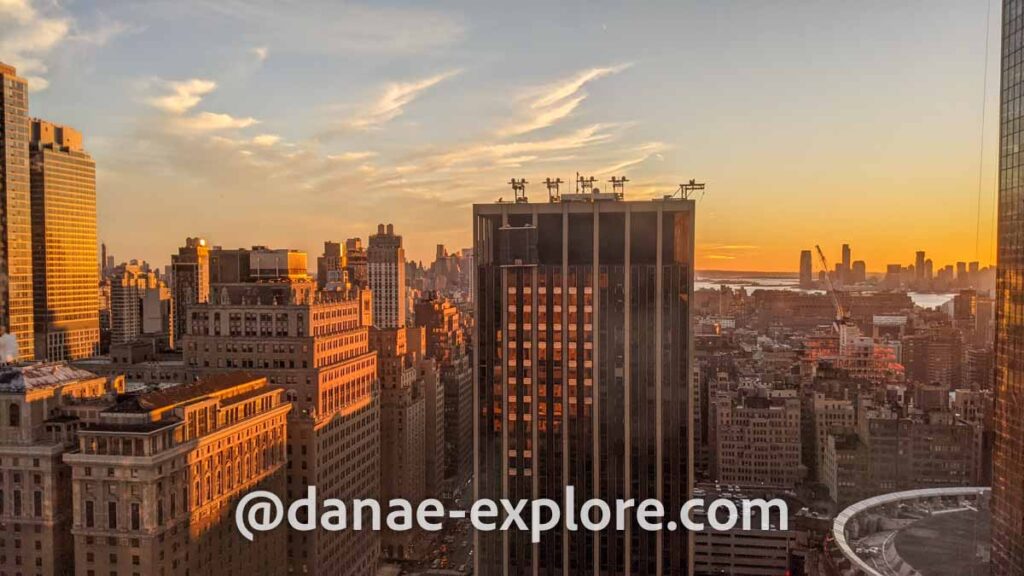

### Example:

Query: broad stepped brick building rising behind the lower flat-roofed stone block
xmin=181 ymin=280 xmax=381 ymax=576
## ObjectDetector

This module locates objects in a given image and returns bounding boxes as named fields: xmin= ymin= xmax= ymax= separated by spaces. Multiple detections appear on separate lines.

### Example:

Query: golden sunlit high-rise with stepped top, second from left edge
xmin=30 ymin=119 xmax=99 ymax=361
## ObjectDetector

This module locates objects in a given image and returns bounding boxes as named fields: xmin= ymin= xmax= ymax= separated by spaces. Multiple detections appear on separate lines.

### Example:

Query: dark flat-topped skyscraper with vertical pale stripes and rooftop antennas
xmin=473 ymin=191 xmax=694 ymax=576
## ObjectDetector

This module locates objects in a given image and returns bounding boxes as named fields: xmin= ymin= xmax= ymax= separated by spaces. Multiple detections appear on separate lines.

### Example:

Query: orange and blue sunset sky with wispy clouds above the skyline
xmin=0 ymin=0 xmax=1000 ymax=271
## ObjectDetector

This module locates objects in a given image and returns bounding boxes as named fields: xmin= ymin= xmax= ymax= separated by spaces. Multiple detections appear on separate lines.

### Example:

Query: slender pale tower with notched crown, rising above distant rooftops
xmin=367 ymin=224 xmax=409 ymax=328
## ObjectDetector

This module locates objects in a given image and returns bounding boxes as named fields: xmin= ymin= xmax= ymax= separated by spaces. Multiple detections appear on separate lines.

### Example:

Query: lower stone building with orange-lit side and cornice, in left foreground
xmin=65 ymin=373 xmax=291 ymax=576
